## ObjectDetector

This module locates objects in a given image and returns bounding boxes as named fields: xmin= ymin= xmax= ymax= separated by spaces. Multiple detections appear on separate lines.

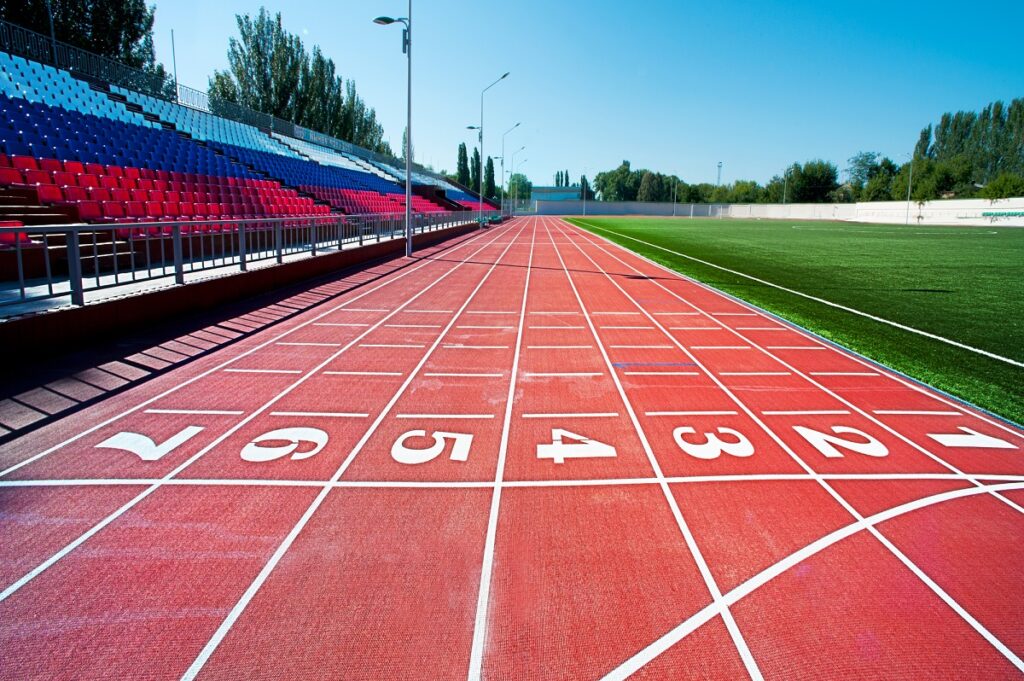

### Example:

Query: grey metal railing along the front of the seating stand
xmin=0 ymin=212 xmax=498 ymax=316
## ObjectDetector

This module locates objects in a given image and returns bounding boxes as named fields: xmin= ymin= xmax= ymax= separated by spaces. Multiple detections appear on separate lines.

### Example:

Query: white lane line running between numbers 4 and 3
xmin=548 ymin=220 xmax=764 ymax=681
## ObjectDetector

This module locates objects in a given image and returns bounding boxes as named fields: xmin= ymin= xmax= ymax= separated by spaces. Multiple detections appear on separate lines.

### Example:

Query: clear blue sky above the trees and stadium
xmin=154 ymin=0 xmax=1024 ymax=184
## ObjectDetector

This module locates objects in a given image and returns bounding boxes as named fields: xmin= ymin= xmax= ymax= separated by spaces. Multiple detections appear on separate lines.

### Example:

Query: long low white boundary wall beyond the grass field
xmin=537 ymin=198 xmax=1024 ymax=227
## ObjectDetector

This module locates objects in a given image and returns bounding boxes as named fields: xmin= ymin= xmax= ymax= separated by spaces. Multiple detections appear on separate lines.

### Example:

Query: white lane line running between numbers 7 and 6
xmin=0 ymin=227 xmax=516 ymax=602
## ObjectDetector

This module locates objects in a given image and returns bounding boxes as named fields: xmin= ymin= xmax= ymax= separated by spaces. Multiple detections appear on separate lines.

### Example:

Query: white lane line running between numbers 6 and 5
xmin=182 ymin=224 xmax=522 ymax=681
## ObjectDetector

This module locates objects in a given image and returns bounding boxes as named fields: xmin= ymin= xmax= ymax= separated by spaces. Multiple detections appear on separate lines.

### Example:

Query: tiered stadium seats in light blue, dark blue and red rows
xmin=0 ymin=52 xmax=476 ymax=227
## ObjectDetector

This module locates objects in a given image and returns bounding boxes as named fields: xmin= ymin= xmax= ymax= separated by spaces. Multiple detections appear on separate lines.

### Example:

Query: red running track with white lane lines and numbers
xmin=0 ymin=218 xmax=1024 ymax=679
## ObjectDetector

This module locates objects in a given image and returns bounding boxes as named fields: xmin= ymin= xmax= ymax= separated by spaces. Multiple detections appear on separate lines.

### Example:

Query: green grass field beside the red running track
xmin=570 ymin=217 xmax=1024 ymax=423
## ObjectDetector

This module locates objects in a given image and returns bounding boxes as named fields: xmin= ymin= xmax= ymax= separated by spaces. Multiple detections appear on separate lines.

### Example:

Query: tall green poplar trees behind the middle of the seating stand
xmin=209 ymin=7 xmax=387 ymax=156
